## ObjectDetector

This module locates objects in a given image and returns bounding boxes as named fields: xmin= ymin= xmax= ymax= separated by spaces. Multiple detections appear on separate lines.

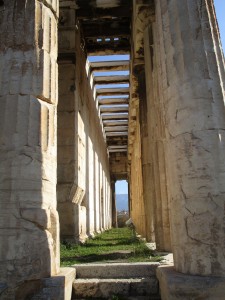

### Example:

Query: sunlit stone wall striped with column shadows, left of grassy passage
xmin=57 ymin=14 xmax=111 ymax=242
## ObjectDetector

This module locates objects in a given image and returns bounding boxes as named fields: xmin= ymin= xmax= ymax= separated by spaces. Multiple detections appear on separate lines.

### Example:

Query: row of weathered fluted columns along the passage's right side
xmin=131 ymin=0 xmax=225 ymax=276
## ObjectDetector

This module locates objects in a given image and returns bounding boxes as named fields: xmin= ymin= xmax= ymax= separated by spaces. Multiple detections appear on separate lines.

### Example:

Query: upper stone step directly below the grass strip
xmin=74 ymin=263 xmax=160 ymax=279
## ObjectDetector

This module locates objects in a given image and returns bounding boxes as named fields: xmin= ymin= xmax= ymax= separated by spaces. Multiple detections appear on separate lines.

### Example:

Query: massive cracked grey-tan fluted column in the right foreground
xmin=155 ymin=0 xmax=225 ymax=276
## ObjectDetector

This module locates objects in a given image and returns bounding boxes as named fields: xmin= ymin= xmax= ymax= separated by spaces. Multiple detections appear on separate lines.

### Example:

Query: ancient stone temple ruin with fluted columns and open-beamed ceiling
xmin=0 ymin=0 xmax=225 ymax=300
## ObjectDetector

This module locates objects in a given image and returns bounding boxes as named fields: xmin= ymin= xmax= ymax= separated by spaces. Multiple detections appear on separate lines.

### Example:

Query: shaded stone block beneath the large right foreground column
xmin=156 ymin=266 xmax=225 ymax=300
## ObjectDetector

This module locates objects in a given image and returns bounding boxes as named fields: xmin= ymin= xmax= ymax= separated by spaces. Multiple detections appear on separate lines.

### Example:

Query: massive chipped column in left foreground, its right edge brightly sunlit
xmin=0 ymin=0 xmax=59 ymax=300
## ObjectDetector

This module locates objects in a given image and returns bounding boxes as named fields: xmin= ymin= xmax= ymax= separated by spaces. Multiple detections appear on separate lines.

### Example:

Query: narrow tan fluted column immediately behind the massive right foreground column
xmin=144 ymin=22 xmax=171 ymax=251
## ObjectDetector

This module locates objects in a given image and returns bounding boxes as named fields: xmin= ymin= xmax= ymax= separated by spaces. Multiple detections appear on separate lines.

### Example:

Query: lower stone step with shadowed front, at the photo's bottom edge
xmin=72 ymin=277 xmax=160 ymax=300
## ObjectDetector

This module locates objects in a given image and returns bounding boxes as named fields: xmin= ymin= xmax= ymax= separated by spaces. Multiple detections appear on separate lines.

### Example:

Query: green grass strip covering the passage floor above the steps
xmin=61 ymin=227 xmax=161 ymax=266
